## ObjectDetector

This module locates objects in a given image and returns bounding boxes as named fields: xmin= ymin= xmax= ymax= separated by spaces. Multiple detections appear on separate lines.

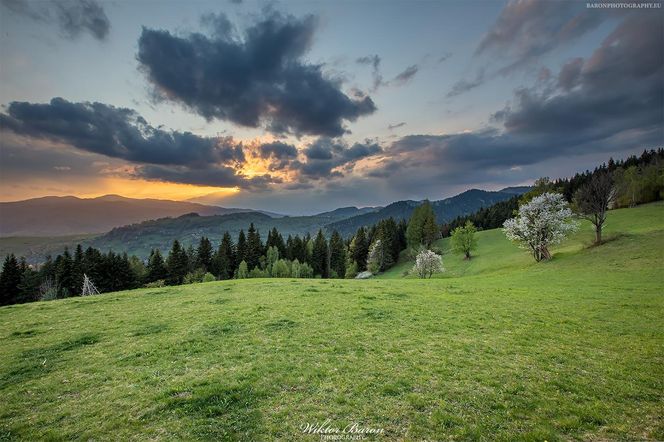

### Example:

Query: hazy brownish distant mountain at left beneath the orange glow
xmin=0 ymin=195 xmax=258 ymax=236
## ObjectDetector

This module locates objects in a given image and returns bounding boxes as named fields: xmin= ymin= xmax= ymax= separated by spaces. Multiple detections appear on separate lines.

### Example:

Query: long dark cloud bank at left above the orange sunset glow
xmin=0 ymin=98 xmax=244 ymax=166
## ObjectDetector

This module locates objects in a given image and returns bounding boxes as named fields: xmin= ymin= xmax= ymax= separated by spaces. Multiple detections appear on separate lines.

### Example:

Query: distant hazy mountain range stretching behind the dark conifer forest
xmin=0 ymin=187 xmax=529 ymax=263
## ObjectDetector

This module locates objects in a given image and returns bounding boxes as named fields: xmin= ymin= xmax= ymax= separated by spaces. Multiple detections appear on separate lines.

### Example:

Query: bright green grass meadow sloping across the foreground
xmin=0 ymin=203 xmax=664 ymax=441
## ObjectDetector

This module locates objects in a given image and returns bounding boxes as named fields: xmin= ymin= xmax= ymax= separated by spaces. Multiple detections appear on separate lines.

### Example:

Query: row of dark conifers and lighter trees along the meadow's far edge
xmin=0 ymin=215 xmax=420 ymax=305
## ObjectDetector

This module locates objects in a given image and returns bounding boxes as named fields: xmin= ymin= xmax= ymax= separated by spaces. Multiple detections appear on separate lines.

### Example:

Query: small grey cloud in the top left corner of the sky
xmin=1 ymin=0 xmax=111 ymax=40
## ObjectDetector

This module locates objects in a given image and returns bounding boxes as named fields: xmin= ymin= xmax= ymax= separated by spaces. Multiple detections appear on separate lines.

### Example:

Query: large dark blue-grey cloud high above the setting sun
xmin=137 ymin=12 xmax=376 ymax=136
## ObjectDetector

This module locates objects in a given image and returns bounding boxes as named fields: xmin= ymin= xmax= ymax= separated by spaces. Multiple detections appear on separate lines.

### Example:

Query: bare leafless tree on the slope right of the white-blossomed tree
xmin=574 ymin=172 xmax=616 ymax=244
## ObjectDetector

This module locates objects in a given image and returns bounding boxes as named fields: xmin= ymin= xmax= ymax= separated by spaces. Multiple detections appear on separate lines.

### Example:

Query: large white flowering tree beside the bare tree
xmin=503 ymin=193 xmax=577 ymax=262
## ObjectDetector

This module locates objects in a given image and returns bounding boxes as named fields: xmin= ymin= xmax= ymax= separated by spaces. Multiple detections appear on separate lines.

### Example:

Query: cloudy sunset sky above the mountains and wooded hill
xmin=0 ymin=0 xmax=664 ymax=214
